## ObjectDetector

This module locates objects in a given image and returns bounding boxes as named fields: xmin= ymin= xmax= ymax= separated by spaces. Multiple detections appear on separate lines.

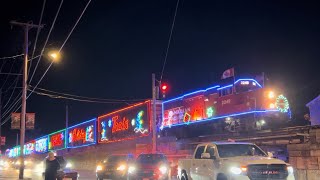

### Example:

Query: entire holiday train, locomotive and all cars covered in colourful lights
xmin=6 ymin=79 xmax=291 ymax=157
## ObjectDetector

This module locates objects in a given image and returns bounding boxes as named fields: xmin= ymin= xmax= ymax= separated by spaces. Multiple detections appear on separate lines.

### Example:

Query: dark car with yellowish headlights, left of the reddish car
xmin=96 ymin=154 xmax=134 ymax=180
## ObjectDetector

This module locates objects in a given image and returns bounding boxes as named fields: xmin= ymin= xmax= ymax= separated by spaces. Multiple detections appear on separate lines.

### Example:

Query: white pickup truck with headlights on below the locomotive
xmin=178 ymin=142 xmax=295 ymax=180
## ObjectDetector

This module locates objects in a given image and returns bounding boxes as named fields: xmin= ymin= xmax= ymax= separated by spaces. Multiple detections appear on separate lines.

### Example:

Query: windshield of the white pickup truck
xmin=217 ymin=144 xmax=267 ymax=158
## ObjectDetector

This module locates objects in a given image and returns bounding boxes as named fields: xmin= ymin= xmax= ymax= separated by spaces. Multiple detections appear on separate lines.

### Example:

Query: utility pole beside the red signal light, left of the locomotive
xmin=152 ymin=74 xmax=157 ymax=153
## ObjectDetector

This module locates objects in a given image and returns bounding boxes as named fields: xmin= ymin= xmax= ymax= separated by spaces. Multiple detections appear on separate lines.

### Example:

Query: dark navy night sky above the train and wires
xmin=0 ymin=0 xmax=320 ymax=149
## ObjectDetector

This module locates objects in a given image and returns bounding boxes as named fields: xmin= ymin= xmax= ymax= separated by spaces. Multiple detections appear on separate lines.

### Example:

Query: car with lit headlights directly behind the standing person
xmin=41 ymin=156 xmax=79 ymax=180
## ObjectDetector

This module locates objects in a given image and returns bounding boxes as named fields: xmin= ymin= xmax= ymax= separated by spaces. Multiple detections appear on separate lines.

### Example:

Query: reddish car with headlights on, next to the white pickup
xmin=129 ymin=154 xmax=170 ymax=180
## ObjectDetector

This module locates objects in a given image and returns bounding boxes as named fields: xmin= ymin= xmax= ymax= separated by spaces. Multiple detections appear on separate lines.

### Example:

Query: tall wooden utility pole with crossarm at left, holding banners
xmin=10 ymin=21 xmax=43 ymax=179
